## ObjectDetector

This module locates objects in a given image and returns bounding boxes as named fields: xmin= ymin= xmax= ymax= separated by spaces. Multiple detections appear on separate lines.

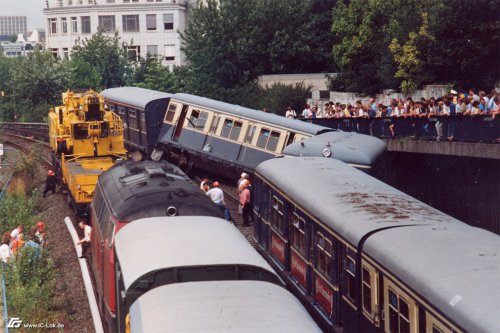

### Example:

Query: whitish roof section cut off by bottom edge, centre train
xmin=129 ymin=281 xmax=321 ymax=333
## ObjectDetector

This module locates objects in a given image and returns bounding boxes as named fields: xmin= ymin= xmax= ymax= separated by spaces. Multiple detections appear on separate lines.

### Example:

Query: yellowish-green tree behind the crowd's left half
xmin=332 ymin=0 xmax=441 ymax=94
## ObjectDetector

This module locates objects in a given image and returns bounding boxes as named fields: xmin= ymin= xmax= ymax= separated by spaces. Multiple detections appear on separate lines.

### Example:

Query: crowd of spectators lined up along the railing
xmin=285 ymin=89 xmax=500 ymax=140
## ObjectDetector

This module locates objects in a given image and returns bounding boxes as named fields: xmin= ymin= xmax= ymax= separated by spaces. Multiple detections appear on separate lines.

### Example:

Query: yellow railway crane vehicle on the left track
xmin=49 ymin=91 xmax=127 ymax=216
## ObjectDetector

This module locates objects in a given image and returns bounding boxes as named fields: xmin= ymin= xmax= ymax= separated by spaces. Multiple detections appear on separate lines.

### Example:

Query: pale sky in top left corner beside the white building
xmin=0 ymin=0 xmax=45 ymax=31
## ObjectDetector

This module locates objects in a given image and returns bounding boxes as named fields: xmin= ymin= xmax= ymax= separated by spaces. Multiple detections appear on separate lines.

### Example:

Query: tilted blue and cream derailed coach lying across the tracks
xmin=158 ymin=94 xmax=385 ymax=175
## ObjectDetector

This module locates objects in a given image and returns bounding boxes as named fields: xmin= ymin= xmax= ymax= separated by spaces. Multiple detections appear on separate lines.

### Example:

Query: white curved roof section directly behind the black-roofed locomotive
xmin=115 ymin=216 xmax=280 ymax=290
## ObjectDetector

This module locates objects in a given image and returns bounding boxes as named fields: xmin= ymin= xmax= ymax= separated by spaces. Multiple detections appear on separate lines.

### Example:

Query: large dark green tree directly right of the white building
xmin=182 ymin=0 xmax=334 ymax=97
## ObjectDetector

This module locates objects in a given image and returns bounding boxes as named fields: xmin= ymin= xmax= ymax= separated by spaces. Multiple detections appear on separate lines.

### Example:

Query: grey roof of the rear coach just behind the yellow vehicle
xmin=101 ymin=87 xmax=172 ymax=109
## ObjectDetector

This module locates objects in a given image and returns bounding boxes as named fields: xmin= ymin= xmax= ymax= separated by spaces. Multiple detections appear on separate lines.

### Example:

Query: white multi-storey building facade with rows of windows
xmin=43 ymin=0 xmax=192 ymax=67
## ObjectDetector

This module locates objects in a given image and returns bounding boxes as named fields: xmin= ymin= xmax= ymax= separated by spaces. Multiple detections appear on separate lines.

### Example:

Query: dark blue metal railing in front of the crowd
xmin=304 ymin=115 xmax=500 ymax=143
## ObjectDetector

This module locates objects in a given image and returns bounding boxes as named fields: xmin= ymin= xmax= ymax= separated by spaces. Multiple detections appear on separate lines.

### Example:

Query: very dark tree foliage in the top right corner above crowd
xmin=427 ymin=0 xmax=500 ymax=92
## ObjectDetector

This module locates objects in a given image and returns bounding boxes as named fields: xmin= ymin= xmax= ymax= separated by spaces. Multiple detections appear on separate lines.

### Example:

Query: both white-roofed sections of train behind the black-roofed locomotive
xmin=115 ymin=216 xmax=320 ymax=333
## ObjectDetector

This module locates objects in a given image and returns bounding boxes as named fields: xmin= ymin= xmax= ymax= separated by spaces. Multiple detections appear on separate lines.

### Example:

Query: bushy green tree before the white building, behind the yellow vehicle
xmin=72 ymin=30 xmax=133 ymax=89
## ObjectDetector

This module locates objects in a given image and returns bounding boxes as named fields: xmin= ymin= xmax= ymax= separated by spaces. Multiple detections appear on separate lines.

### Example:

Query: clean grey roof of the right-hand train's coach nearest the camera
xmin=364 ymin=223 xmax=500 ymax=333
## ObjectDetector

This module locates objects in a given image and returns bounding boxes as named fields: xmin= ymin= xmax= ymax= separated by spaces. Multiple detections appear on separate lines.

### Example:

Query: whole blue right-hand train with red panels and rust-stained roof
xmin=254 ymin=157 xmax=500 ymax=333
